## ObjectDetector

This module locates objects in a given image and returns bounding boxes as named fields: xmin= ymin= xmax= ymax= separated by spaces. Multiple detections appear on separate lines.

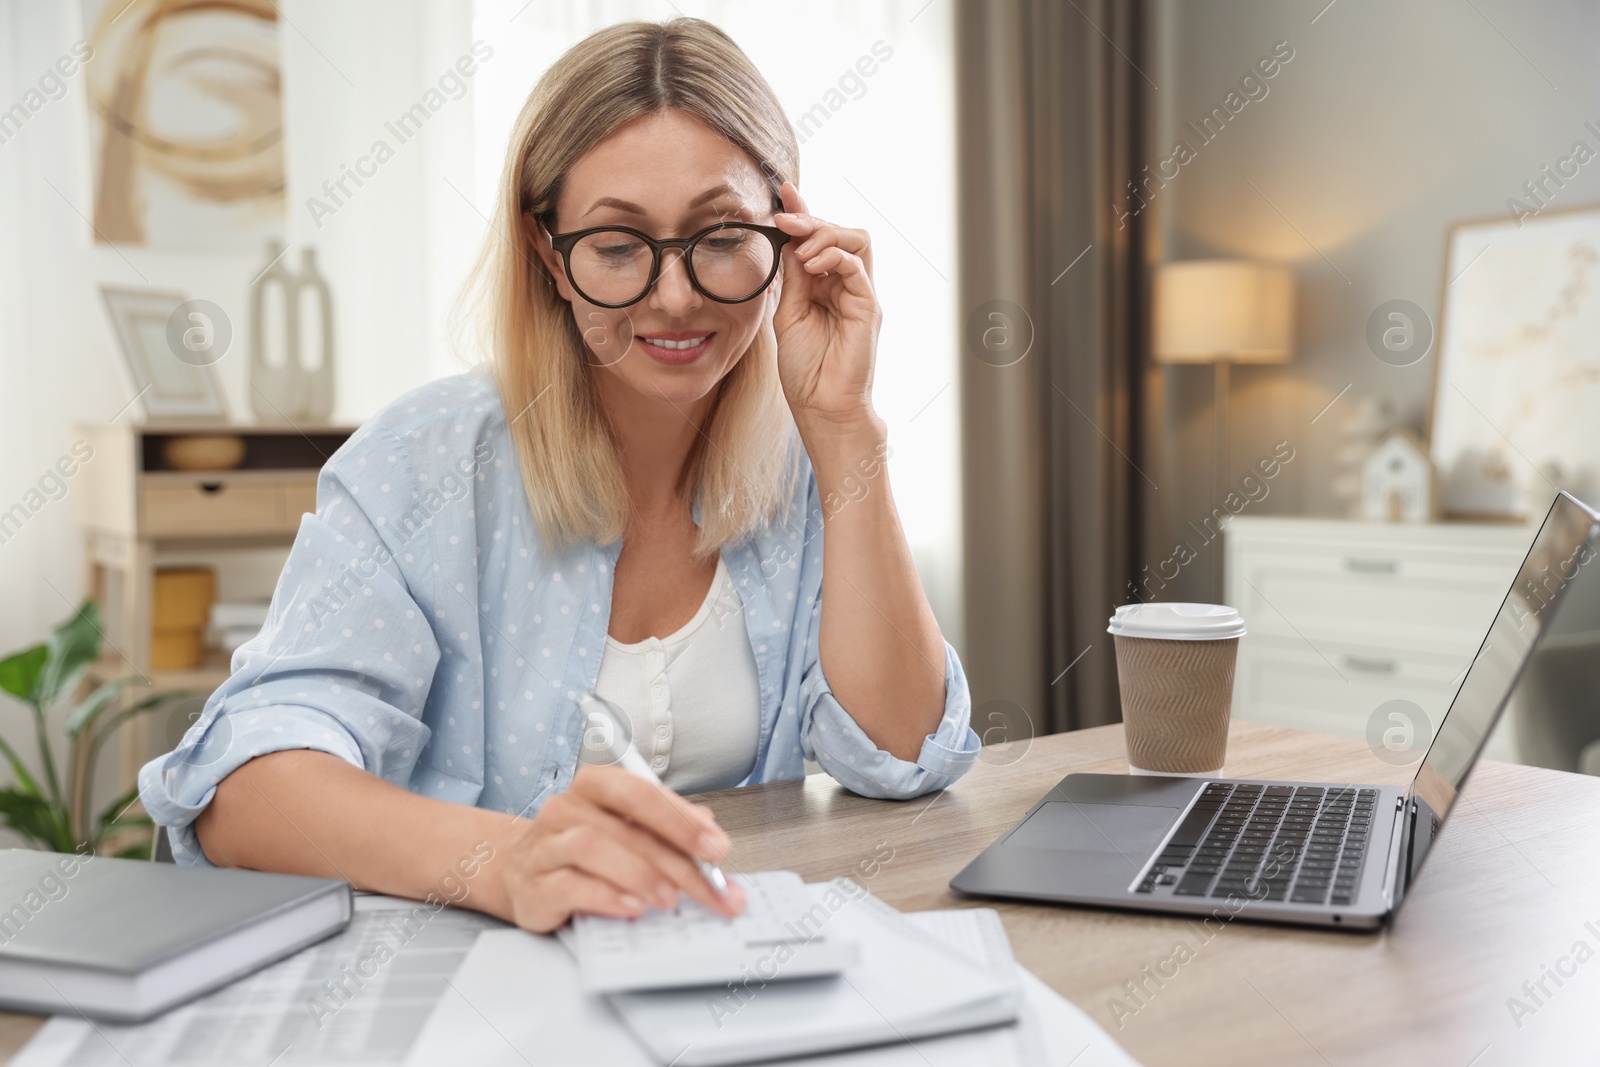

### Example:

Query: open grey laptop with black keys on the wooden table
xmin=950 ymin=493 xmax=1600 ymax=929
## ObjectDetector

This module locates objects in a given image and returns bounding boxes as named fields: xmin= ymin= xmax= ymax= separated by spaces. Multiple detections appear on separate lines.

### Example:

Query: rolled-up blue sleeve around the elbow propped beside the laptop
xmin=800 ymin=638 xmax=981 ymax=800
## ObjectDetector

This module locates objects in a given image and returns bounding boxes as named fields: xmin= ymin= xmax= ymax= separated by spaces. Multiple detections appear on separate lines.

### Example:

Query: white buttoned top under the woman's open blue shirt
xmin=595 ymin=557 xmax=762 ymax=793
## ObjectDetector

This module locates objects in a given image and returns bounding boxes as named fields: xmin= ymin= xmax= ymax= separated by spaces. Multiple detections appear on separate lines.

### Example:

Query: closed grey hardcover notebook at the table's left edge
xmin=0 ymin=849 xmax=350 ymax=1022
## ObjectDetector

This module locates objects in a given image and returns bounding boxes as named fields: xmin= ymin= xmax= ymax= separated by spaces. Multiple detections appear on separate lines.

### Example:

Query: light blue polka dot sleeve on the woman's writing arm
xmin=139 ymin=429 xmax=440 ymax=864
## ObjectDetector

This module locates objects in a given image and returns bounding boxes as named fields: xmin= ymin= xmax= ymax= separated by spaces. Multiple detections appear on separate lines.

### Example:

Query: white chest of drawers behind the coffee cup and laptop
xmin=1224 ymin=517 xmax=1536 ymax=758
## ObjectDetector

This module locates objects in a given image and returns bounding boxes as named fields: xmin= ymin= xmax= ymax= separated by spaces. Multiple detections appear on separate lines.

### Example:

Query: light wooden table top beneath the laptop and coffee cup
xmin=0 ymin=721 xmax=1600 ymax=1067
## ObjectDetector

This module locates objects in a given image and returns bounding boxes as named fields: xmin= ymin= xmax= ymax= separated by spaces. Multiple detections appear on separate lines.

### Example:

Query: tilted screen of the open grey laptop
xmin=1411 ymin=493 xmax=1600 ymax=857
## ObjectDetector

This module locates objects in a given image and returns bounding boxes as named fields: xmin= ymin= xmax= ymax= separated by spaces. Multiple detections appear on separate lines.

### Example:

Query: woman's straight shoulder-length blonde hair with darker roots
xmin=467 ymin=18 xmax=798 ymax=557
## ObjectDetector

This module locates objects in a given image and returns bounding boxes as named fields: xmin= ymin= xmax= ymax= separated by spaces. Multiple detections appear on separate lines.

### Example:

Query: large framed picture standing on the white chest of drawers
xmin=1429 ymin=206 xmax=1600 ymax=520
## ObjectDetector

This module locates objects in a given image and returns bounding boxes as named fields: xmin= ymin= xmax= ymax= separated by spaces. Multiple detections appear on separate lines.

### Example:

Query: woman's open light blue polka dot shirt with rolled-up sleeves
xmin=139 ymin=370 xmax=979 ymax=864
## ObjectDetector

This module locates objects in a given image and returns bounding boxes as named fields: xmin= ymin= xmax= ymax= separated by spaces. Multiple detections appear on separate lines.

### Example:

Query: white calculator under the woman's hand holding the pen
xmin=560 ymin=870 xmax=859 ymax=993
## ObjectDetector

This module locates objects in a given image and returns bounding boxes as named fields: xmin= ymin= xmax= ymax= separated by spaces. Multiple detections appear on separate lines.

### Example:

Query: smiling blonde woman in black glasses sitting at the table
xmin=141 ymin=18 xmax=978 ymax=931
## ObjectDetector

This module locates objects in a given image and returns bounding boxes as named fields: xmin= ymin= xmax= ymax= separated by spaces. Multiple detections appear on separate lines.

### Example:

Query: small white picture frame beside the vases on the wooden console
xmin=101 ymin=286 xmax=227 ymax=421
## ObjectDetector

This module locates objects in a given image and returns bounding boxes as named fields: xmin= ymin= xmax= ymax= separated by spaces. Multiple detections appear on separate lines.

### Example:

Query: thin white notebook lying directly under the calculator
xmin=608 ymin=878 xmax=1019 ymax=1067
